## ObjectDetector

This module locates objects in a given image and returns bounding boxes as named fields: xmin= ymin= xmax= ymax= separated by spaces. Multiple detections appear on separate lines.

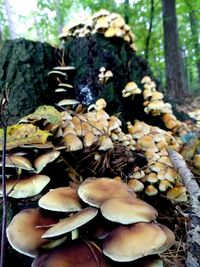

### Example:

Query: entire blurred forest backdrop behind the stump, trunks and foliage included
xmin=0 ymin=0 xmax=200 ymax=98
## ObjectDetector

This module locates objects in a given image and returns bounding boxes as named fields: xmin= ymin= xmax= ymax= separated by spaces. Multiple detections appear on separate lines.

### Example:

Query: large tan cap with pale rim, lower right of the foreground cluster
xmin=103 ymin=223 xmax=167 ymax=262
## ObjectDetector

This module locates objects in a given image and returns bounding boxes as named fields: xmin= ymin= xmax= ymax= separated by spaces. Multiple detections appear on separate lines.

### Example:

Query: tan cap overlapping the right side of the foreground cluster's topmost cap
xmin=100 ymin=197 xmax=158 ymax=224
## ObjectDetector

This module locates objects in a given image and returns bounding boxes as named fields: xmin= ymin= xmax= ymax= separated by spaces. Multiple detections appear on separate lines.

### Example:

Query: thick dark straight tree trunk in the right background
xmin=162 ymin=0 xmax=186 ymax=99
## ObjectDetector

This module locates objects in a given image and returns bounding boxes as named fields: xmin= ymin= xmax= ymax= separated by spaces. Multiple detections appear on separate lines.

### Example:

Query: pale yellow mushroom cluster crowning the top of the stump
xmin=60 ymin=9 xmax=136 ymax=51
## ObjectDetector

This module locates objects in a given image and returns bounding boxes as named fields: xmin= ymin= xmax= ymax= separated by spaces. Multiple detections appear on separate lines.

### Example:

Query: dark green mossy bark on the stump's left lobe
xmin=0 ymin=39 xmax=56 ymax=124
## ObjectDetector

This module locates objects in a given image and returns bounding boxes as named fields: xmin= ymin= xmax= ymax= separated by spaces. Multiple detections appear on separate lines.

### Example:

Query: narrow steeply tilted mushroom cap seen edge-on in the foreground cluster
xmin=42 ymin=207 xmax=98 ymax=238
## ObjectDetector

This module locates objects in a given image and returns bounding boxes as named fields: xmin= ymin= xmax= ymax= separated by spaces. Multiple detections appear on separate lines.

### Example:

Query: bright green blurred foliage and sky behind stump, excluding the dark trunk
xmin=0 ymin=0 xmax=200 ymax=96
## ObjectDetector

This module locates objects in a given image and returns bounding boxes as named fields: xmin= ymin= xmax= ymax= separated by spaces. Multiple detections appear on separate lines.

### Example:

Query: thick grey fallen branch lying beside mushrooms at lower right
xmin=168 ymin=149 xmax=200 ymax=267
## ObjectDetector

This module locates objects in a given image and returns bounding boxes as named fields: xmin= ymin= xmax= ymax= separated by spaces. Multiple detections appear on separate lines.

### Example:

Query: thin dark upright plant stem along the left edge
xmin=0 ymin=126 xmax=7 ymax=267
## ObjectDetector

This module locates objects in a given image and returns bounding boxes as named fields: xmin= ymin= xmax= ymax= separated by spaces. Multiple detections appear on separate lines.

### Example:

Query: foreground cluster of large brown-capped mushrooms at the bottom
xmin=6 ymin=177 xmax=175 ymax=267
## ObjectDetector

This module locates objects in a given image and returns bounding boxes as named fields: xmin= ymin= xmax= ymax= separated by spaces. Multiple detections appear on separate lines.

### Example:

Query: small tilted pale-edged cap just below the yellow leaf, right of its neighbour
xmin=34 ymin=151 xmax=60 ymax=173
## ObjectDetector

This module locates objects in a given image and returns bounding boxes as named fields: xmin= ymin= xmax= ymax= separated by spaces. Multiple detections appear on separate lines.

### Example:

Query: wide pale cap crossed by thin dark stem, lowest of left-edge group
xmin=0 ymin=175 xmax=50 ymax=198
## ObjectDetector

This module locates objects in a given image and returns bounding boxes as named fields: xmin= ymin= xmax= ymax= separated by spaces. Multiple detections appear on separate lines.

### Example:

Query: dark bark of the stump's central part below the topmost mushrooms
xmin=64 ymin=34 xmax=167 ymax=125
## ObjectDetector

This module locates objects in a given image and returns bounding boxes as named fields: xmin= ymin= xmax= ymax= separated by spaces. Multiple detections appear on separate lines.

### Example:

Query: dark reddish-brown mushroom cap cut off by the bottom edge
xmin=31 ymin=240 xmax=110 ymax=267
